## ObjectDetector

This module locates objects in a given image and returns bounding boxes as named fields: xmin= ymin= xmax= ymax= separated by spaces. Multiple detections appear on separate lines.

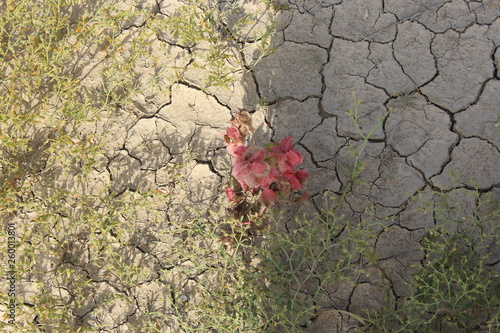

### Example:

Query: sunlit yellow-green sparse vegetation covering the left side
xmin=0 ymin=0 xmax=278 ymax=332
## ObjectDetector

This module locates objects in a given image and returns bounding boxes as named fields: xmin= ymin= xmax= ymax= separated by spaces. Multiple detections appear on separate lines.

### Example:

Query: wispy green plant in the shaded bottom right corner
xmin=364 ymin=190 xmax=500 ymax=332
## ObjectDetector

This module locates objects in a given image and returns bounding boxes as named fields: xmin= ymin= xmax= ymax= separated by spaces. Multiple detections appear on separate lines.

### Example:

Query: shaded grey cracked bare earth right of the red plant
xmin=262 ymin=0 xmax=500 ymax=332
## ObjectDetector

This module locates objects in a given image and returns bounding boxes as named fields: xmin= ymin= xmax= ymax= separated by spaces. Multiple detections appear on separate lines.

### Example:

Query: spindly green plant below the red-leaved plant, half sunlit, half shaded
xmin=156 ymin=191 xmax=375 ymax=332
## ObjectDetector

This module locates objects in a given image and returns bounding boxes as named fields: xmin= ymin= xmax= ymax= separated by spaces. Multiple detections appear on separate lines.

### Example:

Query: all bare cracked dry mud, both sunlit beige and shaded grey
xmin=4 ymin=0 xmax=500 ymax=332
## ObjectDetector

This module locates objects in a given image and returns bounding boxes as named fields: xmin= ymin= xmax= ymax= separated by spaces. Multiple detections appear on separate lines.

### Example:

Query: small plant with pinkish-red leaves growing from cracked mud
xmin=224 ymin=110 xmax=309 ymax=227
